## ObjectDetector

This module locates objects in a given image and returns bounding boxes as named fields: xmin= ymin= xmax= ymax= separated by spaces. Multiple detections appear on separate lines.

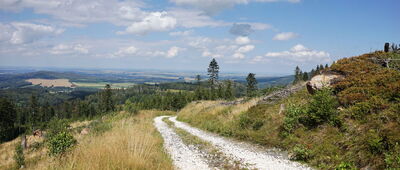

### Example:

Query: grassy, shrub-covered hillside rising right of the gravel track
xmin=178 ymin=52 xmax=400 ymax=169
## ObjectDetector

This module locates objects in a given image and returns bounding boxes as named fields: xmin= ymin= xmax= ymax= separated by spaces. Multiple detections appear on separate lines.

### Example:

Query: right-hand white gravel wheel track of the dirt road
xmin=169 ymin=116 xmax=311 ymax=170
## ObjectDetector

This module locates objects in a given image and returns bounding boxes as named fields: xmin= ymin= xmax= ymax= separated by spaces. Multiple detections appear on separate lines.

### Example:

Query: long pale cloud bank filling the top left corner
xmin=0 ymin=0 xmax=144 ymax=25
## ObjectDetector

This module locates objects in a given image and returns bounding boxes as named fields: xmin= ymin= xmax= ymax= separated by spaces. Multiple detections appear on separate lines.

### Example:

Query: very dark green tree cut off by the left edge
xmin=0 ymin=98 xmax=16 ymax=142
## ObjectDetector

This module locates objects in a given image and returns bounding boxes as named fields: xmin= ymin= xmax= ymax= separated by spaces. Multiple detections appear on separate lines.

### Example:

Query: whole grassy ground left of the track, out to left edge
xmin=0 ymin=110 xmax=173 ymax=170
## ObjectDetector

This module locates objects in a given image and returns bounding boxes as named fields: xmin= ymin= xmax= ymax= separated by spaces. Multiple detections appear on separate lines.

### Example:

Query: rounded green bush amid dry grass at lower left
xmin=48 ymin=132 xmax=76 ymax=156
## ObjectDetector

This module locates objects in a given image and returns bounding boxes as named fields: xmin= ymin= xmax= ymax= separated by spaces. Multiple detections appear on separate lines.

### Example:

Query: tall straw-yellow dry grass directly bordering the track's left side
xmin=45 ymin=111 xmax=173 ymax=170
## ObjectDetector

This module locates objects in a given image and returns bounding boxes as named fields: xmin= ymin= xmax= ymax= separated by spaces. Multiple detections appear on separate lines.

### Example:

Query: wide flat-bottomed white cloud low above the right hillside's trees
xmin=265 ymin=44 xmax=331 ymax=63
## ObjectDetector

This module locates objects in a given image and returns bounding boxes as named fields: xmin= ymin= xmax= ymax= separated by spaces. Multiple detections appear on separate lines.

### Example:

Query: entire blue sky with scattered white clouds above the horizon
xmin=0 ymin=0 xmax=400 ymax=74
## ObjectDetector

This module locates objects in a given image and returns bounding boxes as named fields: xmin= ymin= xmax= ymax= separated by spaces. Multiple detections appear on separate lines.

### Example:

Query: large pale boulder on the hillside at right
xmin=306 ymin=73 xmax=344 ymax=94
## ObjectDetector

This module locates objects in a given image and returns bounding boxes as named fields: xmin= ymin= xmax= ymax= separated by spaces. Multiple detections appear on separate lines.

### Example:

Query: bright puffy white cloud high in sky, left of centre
xmin=120 ymin=12 xmax=176 ymax=35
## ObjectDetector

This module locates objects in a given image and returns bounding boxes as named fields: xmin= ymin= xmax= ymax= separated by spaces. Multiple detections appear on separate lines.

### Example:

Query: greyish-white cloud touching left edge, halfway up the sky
xmin=0 ymin=22 xmax=64 ymax=44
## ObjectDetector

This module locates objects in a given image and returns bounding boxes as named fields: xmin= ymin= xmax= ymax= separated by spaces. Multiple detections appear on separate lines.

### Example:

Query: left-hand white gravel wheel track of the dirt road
xmin=154 ymin=116 xmax=211 ymax=170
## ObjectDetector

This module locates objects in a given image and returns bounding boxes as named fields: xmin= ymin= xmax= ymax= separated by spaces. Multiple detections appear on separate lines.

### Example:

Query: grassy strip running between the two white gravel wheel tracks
xmin=163 ymin=118 xmax=247 ymax=169
